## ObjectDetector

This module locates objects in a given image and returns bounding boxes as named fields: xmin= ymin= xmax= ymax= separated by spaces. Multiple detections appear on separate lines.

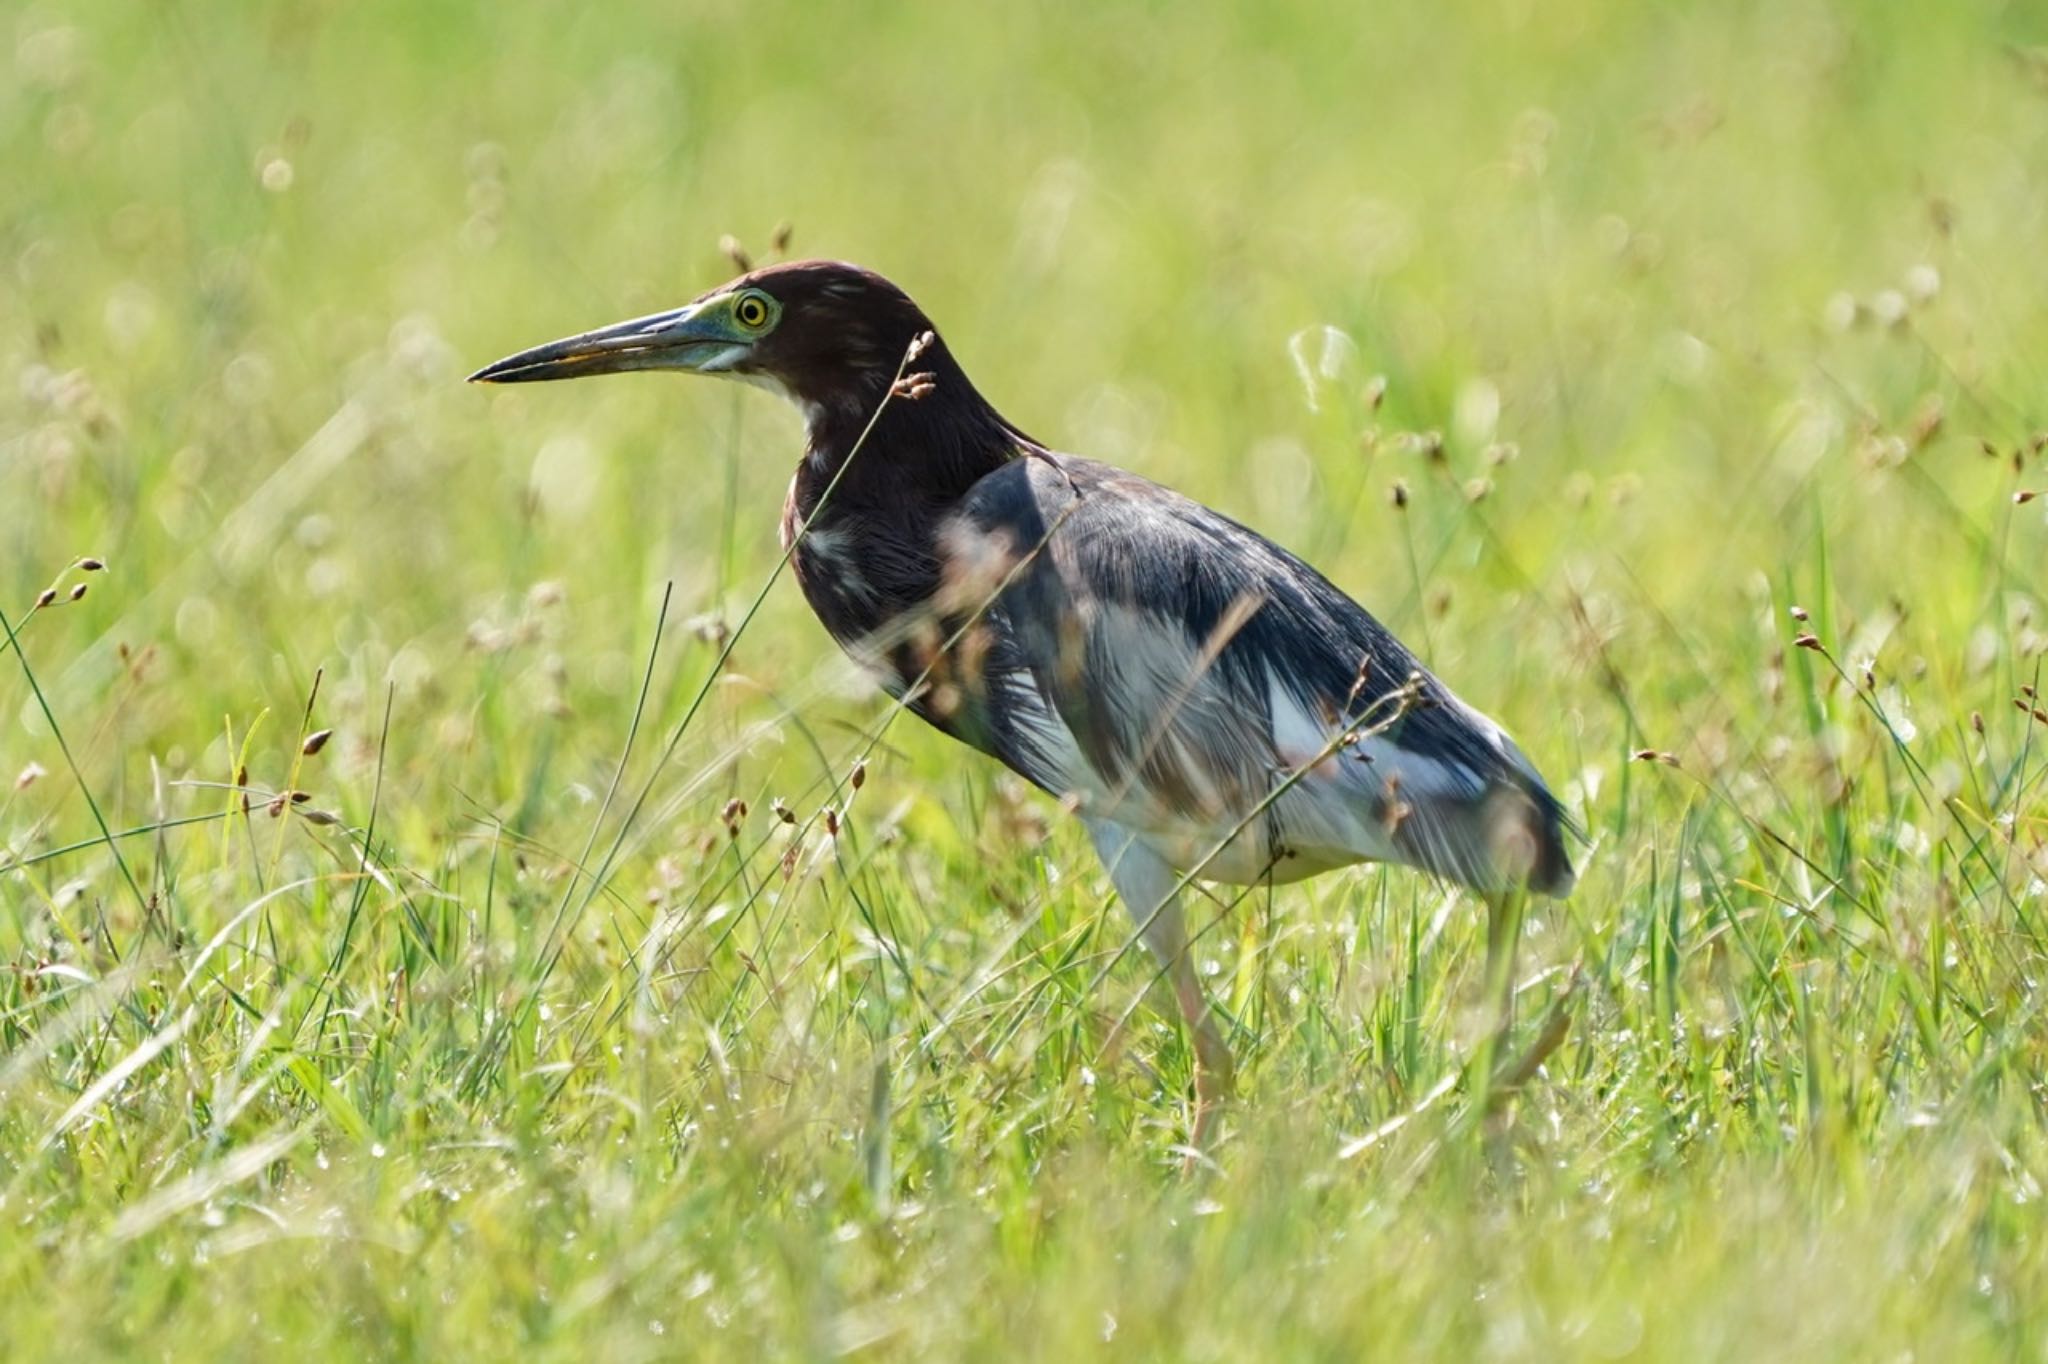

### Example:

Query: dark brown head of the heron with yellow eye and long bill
xmin=469 ymin=260 xmax=950 ymax=422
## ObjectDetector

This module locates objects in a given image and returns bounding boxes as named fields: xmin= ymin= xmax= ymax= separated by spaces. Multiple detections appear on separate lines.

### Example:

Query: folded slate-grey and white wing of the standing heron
xmin=942 ymin=453 xmax=1571 ymax=895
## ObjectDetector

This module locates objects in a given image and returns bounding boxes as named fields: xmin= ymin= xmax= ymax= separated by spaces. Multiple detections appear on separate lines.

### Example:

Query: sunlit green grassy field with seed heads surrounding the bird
xmin=0 ymin=0 xmax=2048 ymax=1360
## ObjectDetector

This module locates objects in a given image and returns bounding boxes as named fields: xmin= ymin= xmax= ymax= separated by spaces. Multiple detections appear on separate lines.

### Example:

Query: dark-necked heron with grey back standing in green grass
xmin=471 ymin=260 xmax=1577 ymax=1147
